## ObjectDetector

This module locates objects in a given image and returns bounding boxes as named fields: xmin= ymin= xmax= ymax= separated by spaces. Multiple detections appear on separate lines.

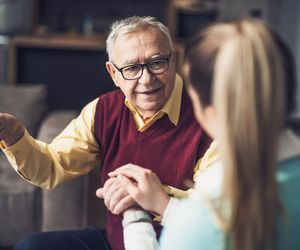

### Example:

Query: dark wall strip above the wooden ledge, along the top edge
xmin=38 ymin=0 xmax=169 ymax=32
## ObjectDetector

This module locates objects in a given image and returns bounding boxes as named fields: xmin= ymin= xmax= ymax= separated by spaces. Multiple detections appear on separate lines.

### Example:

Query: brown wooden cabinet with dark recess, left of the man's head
xmin=9 ymin=35 xmax=115 ymax=109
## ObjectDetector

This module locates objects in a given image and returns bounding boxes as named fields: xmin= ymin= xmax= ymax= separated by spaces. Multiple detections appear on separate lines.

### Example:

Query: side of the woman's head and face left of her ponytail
xmin=183 ymin=23 xmax=239 ymax=138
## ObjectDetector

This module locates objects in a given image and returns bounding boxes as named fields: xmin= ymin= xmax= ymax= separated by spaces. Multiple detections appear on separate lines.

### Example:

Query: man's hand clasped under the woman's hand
xmin=96 ymin=177 xmax=136 ymax=214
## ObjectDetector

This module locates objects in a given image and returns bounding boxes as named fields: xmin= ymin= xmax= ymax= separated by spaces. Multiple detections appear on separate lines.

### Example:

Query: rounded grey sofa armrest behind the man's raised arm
xmin=38 ymin=110 xmax=88 ymax=231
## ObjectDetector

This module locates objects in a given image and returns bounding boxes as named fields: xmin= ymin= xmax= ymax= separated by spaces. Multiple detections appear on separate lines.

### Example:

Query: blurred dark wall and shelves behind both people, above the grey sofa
xmin=0 ymin=0 xmax=300 ymax=115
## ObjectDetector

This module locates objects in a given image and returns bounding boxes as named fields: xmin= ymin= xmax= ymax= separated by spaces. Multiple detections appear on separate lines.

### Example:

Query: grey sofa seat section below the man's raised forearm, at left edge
xmin=0 ymin=152 xmax=42 ymax=246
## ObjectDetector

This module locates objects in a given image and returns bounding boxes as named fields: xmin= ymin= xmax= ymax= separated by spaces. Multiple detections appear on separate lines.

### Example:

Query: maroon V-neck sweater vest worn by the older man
xmin=95 ymin=90 xmax=210 ymax=250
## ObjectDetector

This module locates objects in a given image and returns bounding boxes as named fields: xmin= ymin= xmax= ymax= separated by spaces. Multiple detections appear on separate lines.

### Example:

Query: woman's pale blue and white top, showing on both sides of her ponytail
xmin=124 ymin=129 xmax=300 ymax=250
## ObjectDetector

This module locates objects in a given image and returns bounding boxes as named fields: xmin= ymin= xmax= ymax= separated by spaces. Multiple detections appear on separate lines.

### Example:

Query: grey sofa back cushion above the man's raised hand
xmin=0 ymin=84 xmax=47 ymax=136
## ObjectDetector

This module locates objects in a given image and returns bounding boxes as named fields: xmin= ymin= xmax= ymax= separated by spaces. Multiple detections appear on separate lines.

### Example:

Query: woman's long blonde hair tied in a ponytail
xmin=186 ymin=19 xmax=285 ymax=250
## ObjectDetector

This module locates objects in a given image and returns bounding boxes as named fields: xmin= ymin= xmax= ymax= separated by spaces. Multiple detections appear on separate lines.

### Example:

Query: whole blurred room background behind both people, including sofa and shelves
xmin=0 ymin=0 xmax=300 ymax=250
